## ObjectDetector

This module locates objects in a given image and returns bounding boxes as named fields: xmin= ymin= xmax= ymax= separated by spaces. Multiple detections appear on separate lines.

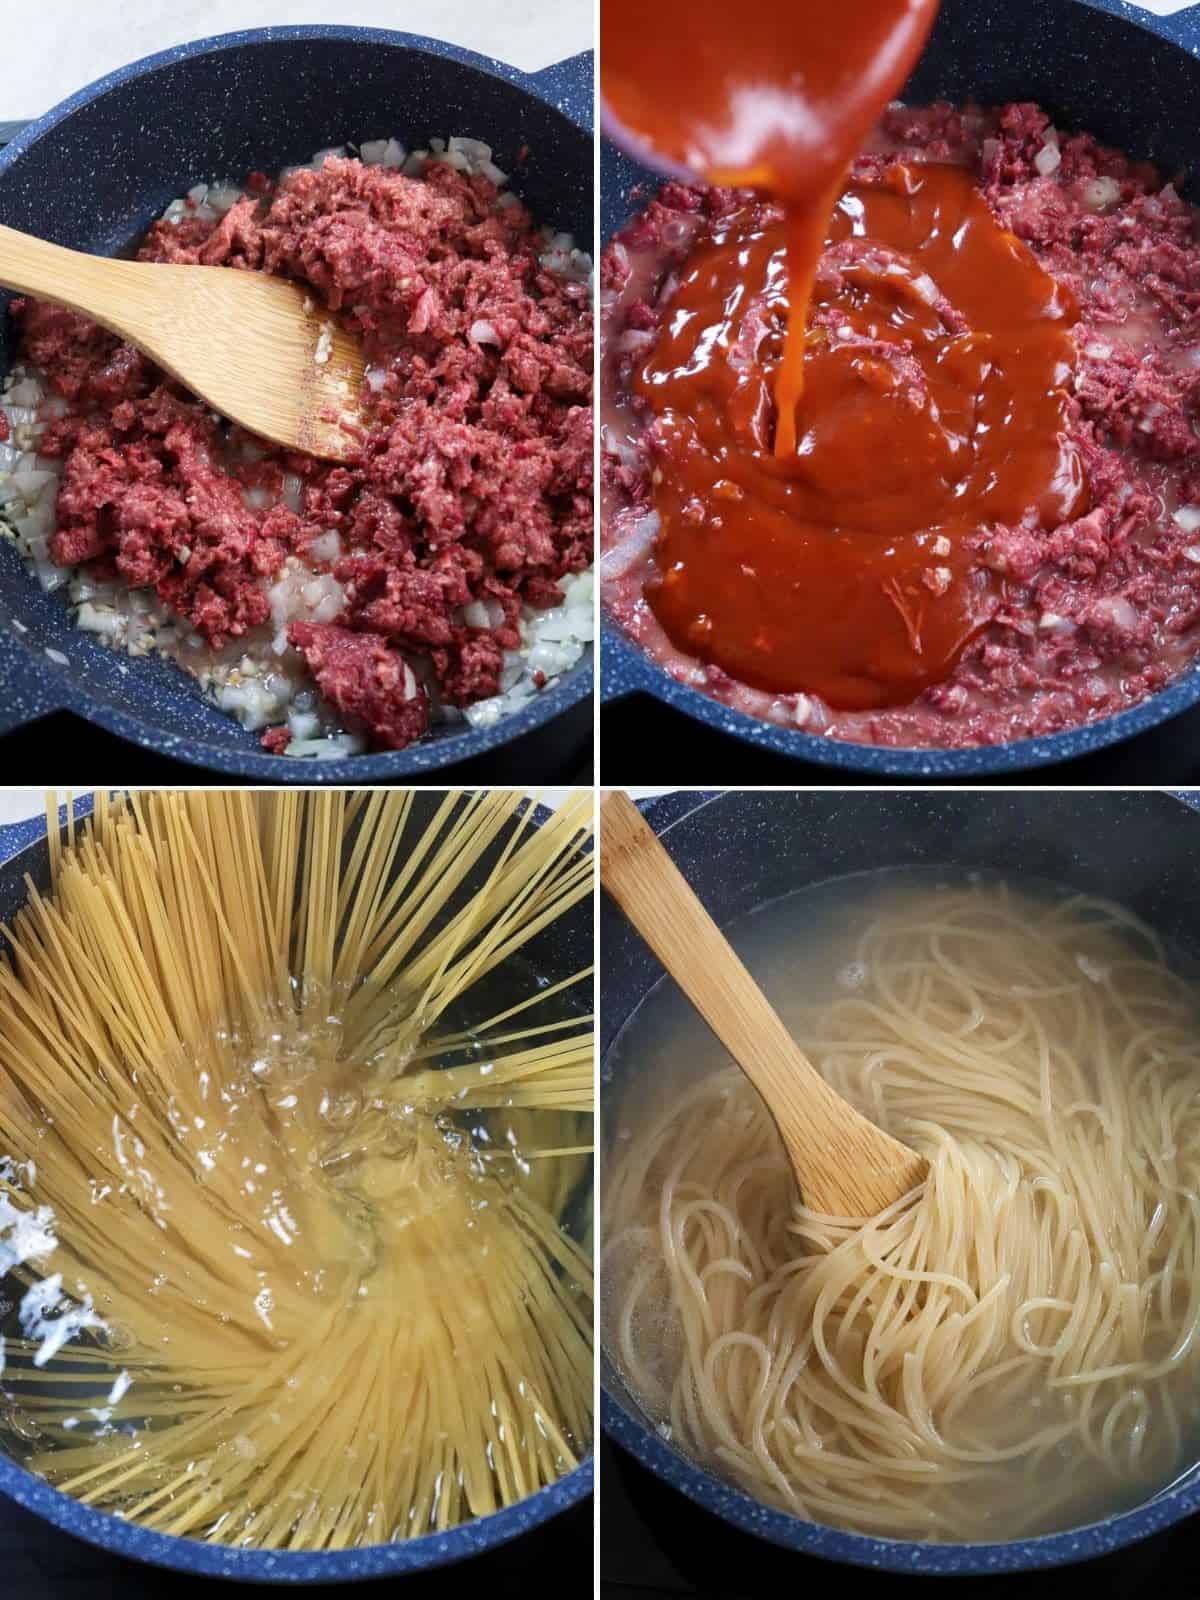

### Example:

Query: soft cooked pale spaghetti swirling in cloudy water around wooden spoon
xmin=603 ymin=883 xmax=1200 ymax=1541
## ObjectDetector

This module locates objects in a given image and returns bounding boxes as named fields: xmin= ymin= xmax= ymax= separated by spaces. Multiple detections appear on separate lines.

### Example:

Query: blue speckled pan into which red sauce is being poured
xmin=611 ymin=0 xmax=1200 ymax=779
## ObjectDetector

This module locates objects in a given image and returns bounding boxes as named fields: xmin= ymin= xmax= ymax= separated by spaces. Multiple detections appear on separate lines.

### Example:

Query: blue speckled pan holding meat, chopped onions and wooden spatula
xmin=0 ymin=27 xmax=594 ymax=784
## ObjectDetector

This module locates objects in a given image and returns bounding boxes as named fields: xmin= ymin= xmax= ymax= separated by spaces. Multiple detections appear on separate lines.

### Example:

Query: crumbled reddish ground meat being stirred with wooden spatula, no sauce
xmin=14 ymin=157 xmax=592 ymax=750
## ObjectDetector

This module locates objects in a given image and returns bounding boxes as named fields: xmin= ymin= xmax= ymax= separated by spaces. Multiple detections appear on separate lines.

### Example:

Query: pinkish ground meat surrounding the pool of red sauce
xmin=600 ymin=104 xmax=1200 ymax=747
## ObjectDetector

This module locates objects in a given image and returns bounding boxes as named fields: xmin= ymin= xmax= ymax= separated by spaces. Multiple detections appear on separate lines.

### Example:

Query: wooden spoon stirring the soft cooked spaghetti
xmin=600 ymin=790 xmax=928 ymax=1218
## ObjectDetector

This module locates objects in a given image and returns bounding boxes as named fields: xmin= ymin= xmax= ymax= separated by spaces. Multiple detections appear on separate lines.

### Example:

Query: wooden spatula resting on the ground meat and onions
xmin=0 ymin=227 xmax=363 ymax=461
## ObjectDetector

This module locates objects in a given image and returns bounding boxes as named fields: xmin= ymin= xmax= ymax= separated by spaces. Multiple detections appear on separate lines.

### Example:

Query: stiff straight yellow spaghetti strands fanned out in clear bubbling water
xmin=0 ymin=792 xmax=592 ymax=1549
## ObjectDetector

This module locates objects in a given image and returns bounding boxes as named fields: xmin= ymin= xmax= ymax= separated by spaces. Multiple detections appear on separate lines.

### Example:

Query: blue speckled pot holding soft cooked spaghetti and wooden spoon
xmin=600 ymin=789 xmax=1200 ymax=1576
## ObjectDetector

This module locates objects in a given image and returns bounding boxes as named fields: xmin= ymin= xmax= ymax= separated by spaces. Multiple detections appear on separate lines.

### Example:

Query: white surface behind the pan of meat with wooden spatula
xmin=0 ymin=0 xmax=592 ymax=122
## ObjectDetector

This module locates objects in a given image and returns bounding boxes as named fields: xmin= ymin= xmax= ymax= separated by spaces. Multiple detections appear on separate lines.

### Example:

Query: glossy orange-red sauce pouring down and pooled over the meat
xmin=602 ymin=0 xmax=1086 ymax=710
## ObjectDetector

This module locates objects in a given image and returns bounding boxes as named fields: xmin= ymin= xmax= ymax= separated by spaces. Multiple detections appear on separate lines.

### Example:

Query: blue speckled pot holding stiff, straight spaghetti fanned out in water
xmin=0 ymin=790 xmax=594 ymax=1574
